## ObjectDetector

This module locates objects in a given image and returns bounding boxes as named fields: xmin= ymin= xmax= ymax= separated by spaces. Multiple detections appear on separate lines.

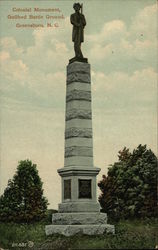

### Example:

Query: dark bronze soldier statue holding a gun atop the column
xmin=70 ymin=3 xmax=86 ymax=59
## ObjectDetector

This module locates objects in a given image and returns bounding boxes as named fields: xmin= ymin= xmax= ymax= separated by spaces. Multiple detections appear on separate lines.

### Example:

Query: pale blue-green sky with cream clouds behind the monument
xmin=0 ymin=0 xmax=158 ymax=209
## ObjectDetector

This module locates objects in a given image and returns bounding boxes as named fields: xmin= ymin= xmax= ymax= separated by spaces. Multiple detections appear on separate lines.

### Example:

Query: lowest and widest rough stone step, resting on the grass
xmin=45 ymin=224 xmax=115 ymax=236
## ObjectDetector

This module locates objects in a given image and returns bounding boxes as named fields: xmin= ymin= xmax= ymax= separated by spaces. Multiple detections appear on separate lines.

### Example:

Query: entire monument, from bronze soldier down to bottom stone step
xmin=45 ymin=3 xmax=115 ymax=236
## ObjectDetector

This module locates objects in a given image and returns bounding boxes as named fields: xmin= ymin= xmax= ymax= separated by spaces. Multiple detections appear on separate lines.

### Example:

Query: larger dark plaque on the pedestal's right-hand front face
xmin=78 ymin=179 xmax=92 ymax=199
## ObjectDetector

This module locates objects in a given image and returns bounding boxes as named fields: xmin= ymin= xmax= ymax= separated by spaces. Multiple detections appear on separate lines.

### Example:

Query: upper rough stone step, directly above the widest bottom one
xmin=52 ymin=212 xmax=107 ymax=225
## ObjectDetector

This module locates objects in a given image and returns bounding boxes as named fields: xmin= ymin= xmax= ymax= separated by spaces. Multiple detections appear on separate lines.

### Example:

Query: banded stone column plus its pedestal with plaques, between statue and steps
xmin=58 ymin=62 xmax=100 ymax=212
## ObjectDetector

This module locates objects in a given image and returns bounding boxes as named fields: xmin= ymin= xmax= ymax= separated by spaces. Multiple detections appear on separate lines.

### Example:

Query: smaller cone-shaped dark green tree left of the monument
xmin=0 ymin=160 xmax=48 ymax=222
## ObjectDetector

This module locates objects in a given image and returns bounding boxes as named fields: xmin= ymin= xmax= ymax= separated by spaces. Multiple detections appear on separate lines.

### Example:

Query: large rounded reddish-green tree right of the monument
xmin=98 ymin=145 xmax=158 ymax=218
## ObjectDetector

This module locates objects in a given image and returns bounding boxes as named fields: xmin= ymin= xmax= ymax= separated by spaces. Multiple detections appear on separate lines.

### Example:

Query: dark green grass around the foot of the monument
xmin=0 ymin=214 xmax=158 ymax=250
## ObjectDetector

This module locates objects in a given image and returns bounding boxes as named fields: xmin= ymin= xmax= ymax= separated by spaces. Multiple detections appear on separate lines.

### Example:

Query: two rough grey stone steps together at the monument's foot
xmin=45 ymin=212 xmax=115 ymax=236
